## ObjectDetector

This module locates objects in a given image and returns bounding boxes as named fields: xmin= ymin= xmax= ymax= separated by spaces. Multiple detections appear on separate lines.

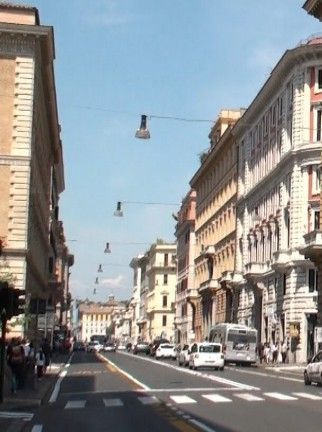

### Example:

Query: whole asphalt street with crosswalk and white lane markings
xmin=13 ymin=352 xmax=322 ymax=432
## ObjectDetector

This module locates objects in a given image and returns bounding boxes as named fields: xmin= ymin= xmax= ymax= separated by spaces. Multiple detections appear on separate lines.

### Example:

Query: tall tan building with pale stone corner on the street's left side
xmin=0 ymin=3 xmax=70 ymax=337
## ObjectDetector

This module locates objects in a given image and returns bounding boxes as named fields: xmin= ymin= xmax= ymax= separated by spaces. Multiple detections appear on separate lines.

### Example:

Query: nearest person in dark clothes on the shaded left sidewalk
xmin=7 ymin=338 xmax=25 ymax=393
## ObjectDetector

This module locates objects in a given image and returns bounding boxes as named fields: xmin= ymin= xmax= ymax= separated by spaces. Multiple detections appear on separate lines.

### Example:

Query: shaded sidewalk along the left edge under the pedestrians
xmin=0 ymin=353 xmax=70 ymax=432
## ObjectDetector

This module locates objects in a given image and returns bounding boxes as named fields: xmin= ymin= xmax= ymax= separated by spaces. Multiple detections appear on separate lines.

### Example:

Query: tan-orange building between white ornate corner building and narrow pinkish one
xmin=190 ymin=109 xmax=244 ymax=340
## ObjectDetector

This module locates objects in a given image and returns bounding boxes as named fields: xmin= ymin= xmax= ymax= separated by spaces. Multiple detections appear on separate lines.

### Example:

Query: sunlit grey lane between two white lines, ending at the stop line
xmin=104 ymin=353 xmax=255 ymax=390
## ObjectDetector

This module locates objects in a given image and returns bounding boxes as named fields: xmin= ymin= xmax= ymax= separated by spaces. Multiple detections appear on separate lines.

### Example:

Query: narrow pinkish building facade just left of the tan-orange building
xmin=174 ymin=190 xmax=199 ymax=344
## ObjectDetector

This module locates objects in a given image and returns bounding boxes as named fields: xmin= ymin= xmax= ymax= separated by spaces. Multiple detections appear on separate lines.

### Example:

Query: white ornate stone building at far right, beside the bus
xmin=233 ymin=38 xmax=322 ymax=361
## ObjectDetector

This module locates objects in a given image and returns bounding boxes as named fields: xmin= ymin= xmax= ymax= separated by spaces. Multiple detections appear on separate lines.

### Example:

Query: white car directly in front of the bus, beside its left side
xmin=189 ymin=342 xmax=225 ymax=371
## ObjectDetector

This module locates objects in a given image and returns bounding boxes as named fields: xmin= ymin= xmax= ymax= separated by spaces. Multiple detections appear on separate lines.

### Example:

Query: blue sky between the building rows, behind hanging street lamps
xmin=18 ymin=0 xmax=322 ymax=301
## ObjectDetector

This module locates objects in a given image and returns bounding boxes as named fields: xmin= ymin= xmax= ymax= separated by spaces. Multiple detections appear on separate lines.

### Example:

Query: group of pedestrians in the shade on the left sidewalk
xmin=6 ymin=338 xmax=51 ymax=393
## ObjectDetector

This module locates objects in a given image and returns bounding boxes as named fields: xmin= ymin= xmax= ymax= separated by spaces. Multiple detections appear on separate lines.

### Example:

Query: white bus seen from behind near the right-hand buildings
xmin=208 ymin=323 xmax=257 ymax=365
